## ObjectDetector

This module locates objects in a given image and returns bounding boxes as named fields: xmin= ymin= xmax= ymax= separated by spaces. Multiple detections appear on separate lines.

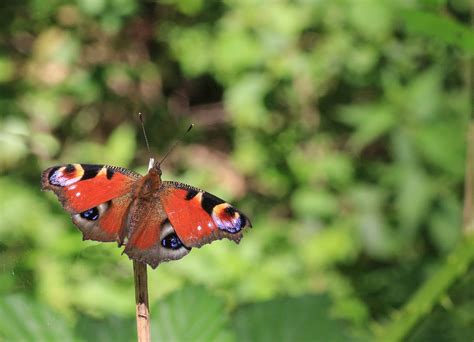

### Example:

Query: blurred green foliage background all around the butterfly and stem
xmin=0 ymin=0 xmax=474 ymax=341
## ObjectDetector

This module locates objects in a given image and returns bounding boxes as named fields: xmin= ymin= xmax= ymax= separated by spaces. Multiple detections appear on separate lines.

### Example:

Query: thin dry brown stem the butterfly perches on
xmin=133 ymin=260 xmax=151 ymax=342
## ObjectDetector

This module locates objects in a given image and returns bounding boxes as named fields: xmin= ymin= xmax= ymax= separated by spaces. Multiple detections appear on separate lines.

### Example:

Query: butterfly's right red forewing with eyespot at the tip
xmin=160 ymin=182 xmax=251 ymax=247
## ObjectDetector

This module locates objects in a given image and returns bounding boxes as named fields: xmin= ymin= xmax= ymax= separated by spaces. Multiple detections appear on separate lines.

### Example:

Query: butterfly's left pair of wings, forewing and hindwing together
xmin=41 ymin=164 xmax=141 ymax=243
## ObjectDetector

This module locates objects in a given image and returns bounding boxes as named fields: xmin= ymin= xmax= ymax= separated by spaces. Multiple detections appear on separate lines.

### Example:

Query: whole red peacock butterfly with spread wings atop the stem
xmin=41 ymin=161 xmax=251 ymax=268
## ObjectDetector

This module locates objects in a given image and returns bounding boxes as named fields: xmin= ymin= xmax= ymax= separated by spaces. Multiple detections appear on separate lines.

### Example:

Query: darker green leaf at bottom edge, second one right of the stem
xmin=233 ymin=295 xmax=348 ymax=342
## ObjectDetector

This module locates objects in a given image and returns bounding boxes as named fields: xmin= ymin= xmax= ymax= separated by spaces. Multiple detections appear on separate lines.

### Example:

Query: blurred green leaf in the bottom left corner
xmin=0 ymin=295 xmax=73 ymax=341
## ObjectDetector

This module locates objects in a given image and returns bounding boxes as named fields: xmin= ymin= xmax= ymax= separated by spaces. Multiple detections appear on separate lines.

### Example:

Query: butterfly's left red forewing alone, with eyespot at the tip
xmin=41 ymin=164 xmax=141 ymax=214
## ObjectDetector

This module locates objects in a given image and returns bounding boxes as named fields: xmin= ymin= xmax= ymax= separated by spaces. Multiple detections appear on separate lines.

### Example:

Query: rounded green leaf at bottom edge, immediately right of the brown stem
xmin=151 ymin=287 xmax=232 ymax=341
